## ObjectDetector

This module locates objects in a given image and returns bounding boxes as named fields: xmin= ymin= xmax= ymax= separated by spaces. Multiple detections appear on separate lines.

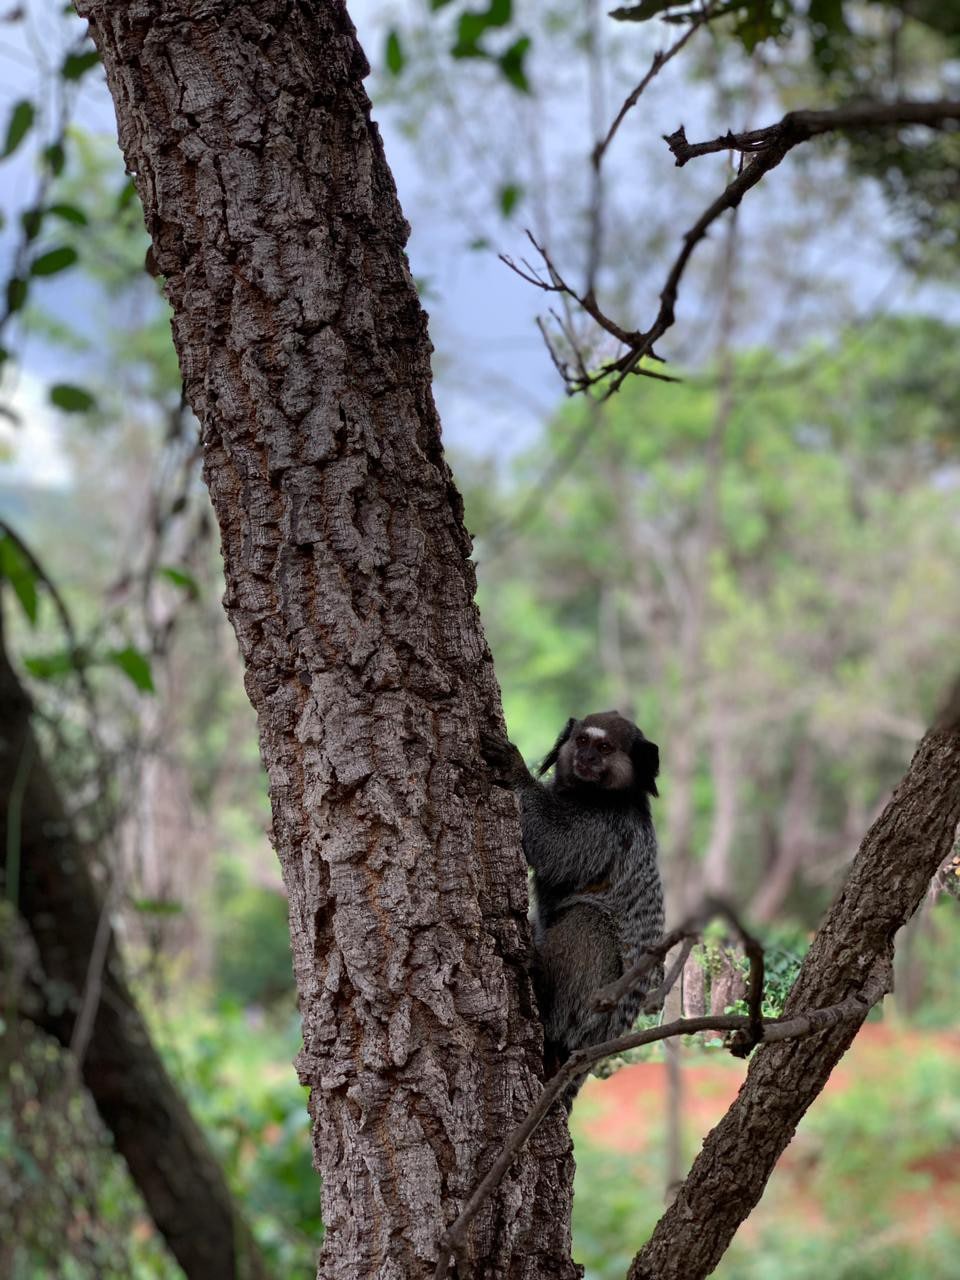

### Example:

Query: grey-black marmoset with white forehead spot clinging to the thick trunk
xmin=485 ymin=712 xmax=663 ymax=1107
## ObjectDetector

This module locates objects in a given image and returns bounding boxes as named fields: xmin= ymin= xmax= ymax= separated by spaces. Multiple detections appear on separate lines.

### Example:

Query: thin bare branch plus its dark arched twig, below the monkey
xmin=434 ymin=900 xmax=886 ymax=1280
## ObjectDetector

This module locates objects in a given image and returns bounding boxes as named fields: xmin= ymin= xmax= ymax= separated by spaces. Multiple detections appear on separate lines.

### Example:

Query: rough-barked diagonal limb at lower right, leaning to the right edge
xmin=630 ymin=686 xmax=960 ymax=1280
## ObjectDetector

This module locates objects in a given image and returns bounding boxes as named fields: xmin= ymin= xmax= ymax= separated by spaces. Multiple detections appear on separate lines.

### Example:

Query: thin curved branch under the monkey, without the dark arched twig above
xmin=434 ymin=972 xmax=886 ymax=1280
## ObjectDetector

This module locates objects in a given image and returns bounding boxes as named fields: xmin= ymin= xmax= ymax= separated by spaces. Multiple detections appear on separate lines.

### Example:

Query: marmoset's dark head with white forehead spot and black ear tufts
xmin=541 ymin=712 xmax=659 ymax=795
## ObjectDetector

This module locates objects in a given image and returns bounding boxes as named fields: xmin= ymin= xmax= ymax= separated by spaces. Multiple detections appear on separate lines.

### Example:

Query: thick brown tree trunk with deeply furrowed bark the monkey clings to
xmin=78 ymin=0 xmax=576 ymax=1280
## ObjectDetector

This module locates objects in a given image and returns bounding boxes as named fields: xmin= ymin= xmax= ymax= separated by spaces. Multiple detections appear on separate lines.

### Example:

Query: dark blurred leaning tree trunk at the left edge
xmin=0 ymin=609 xmax=268 ymax=1280
